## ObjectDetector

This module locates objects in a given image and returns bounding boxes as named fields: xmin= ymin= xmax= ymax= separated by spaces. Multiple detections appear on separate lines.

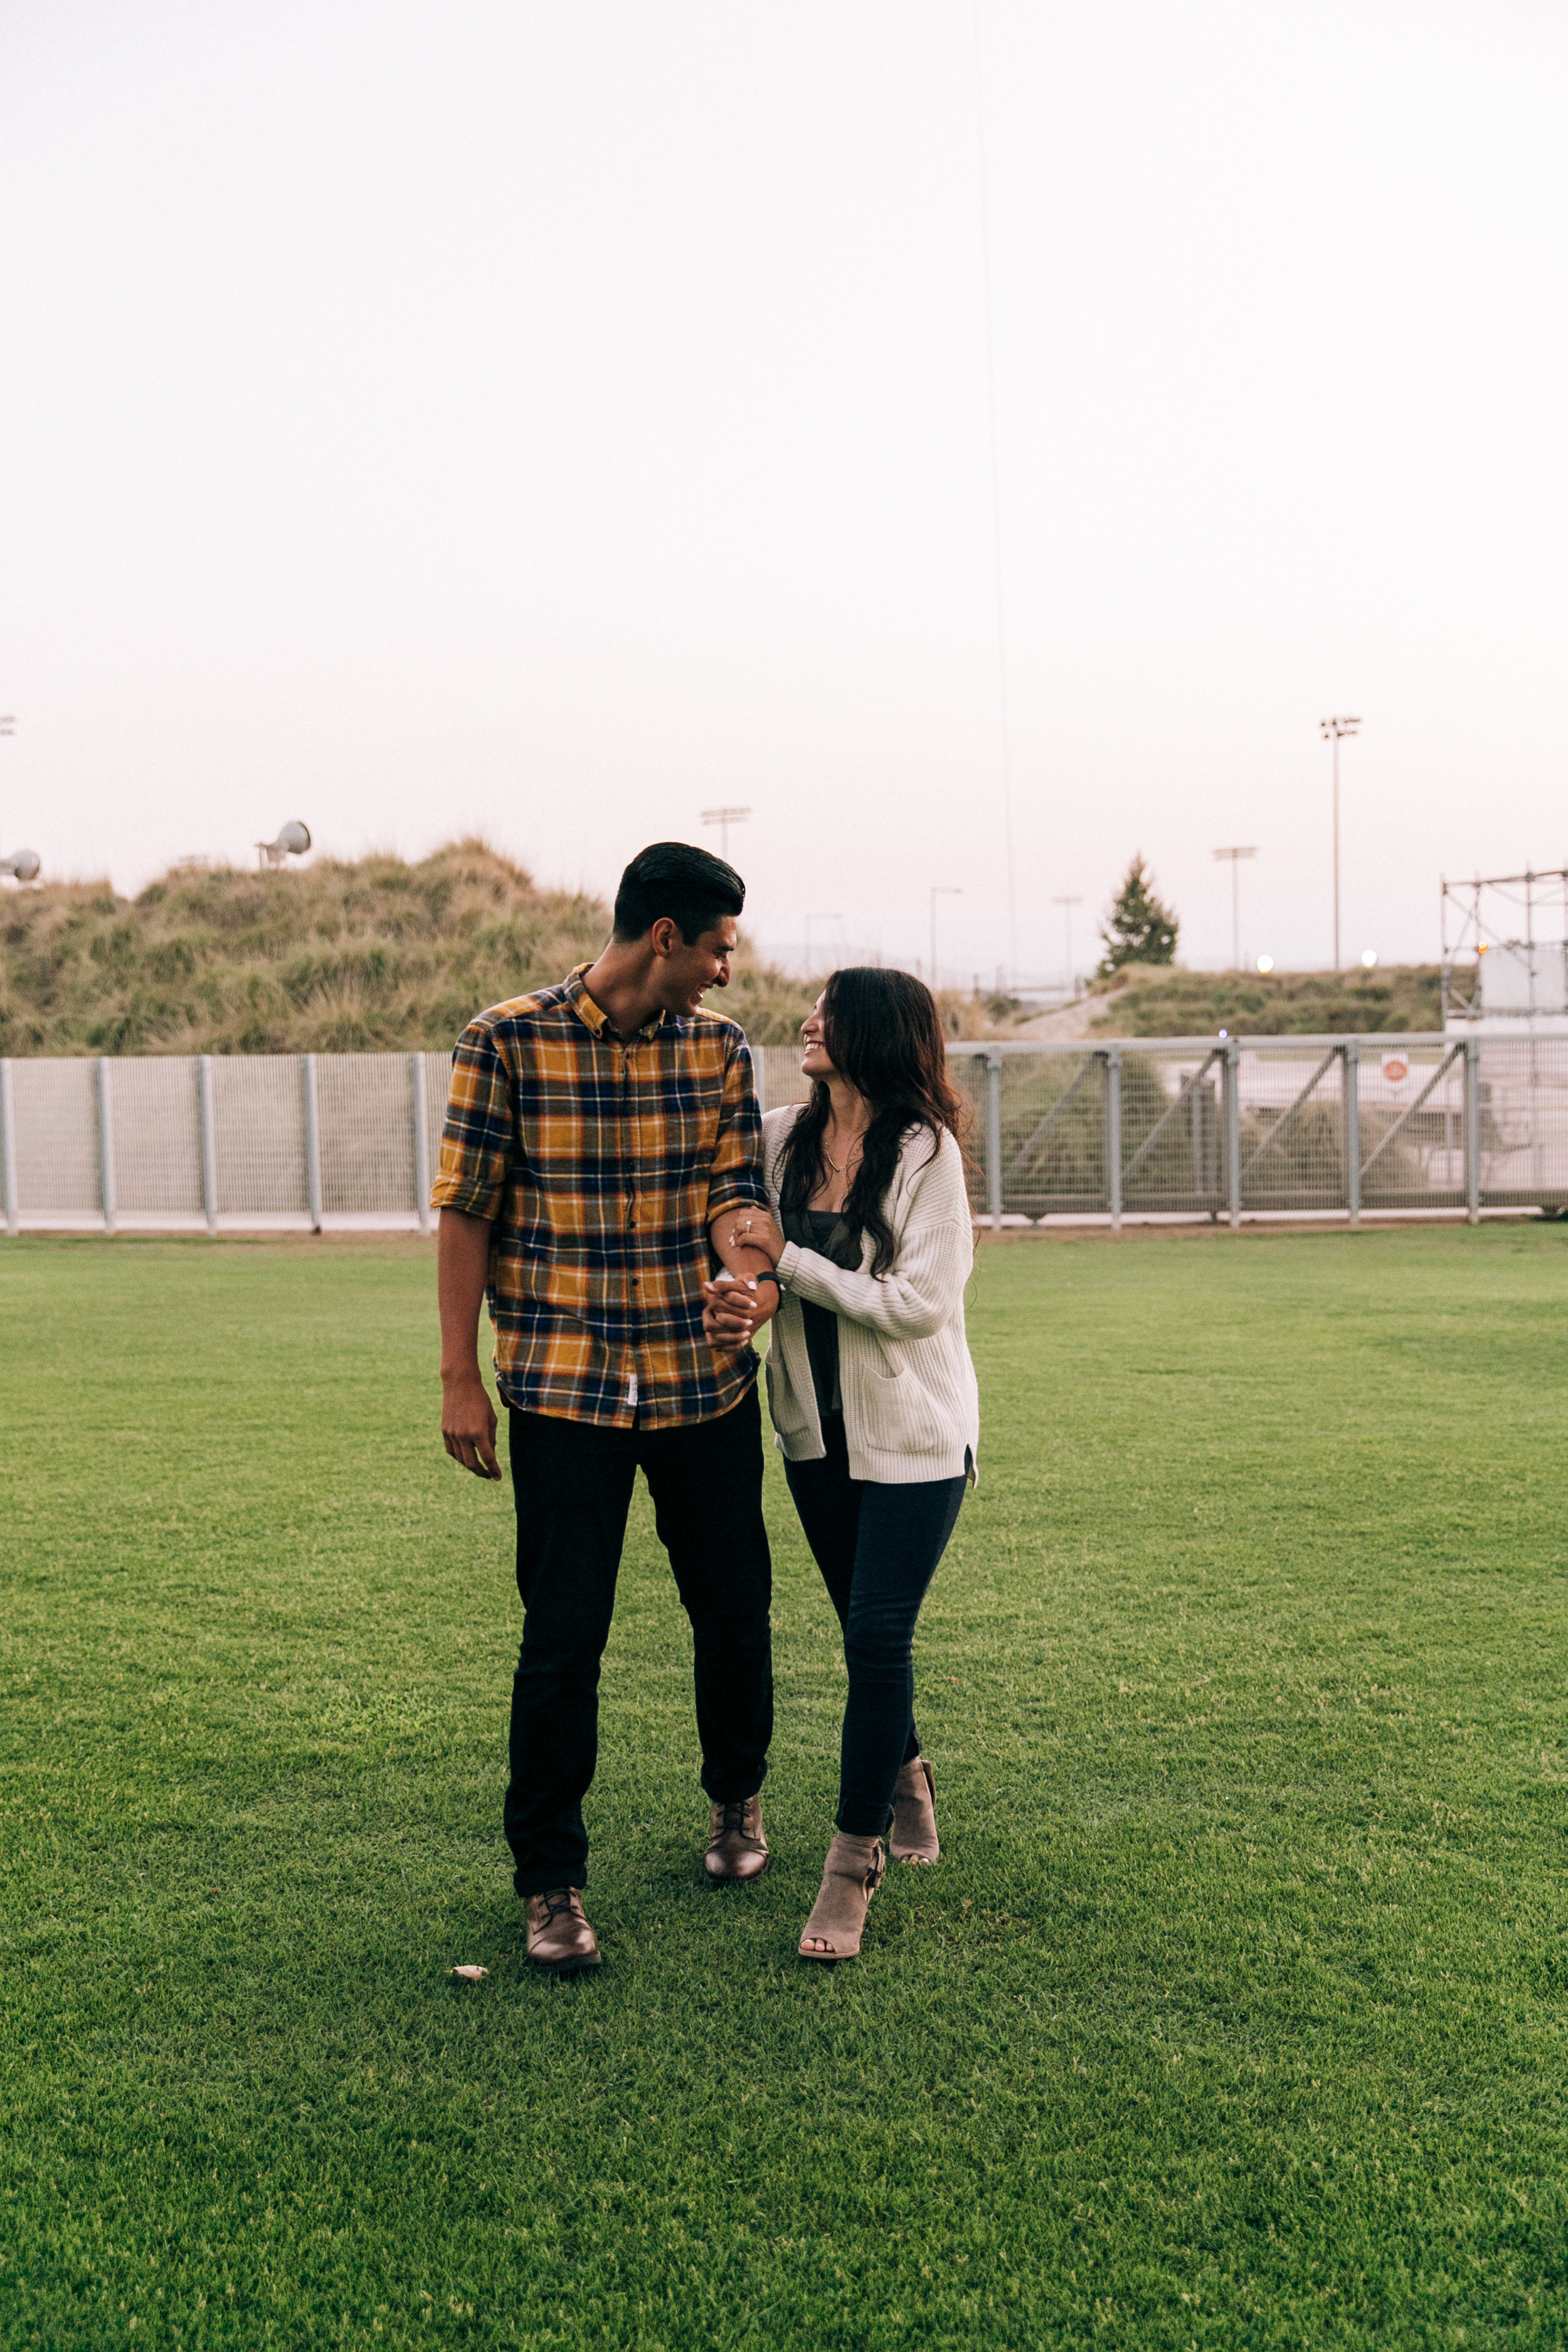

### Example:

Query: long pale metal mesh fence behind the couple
xmin=0 ymin=1035 xmax=1568 ymax=1232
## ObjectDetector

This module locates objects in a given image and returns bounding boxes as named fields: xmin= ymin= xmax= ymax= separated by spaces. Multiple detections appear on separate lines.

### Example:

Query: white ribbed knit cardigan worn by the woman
xmin=761 ymin=1103 xmax=980 ymax=1486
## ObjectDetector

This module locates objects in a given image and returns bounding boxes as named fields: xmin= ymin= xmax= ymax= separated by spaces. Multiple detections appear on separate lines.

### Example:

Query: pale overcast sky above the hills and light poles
xmin=0 ymin=0 xmax=1568 ymax=974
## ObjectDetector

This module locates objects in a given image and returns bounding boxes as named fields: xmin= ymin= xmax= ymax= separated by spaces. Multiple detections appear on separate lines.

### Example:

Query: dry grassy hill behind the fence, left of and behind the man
xmin=0 ymin=840 xmax=813 ymax=1054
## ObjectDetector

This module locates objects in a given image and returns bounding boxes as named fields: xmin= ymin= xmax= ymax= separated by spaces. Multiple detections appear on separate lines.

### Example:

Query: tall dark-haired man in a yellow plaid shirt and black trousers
xmin=430 ymin=842 xmax=780 ymax=1971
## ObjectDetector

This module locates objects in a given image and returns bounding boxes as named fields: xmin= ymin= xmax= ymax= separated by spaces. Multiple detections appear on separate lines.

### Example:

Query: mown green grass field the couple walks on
xmin=0 ymin=1226 xmax=1568 ymax=2352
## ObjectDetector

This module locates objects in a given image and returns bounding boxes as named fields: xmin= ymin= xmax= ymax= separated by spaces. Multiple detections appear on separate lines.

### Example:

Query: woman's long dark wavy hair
xmin=780 ymin=965 xmax=968 ymax=1275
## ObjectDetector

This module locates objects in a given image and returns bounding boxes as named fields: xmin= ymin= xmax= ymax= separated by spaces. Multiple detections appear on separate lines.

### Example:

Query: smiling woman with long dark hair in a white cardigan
xmin=707 ymin=969 xmax=980 ymax=1959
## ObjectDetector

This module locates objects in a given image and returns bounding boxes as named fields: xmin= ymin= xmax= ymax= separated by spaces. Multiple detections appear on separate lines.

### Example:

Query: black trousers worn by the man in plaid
xmin=506 ymin=1385 xmax=773 ymax=1896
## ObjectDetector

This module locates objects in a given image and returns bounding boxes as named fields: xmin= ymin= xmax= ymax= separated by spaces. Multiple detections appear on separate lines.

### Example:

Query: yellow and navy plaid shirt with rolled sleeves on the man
xmin=430 ymin=965 xmax=766 ymax=1428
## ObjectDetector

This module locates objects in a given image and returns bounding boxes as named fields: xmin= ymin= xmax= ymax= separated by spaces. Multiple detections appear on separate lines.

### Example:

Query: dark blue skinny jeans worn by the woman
xmin=785 ymin=1414 xmax=968 ymax=1837
